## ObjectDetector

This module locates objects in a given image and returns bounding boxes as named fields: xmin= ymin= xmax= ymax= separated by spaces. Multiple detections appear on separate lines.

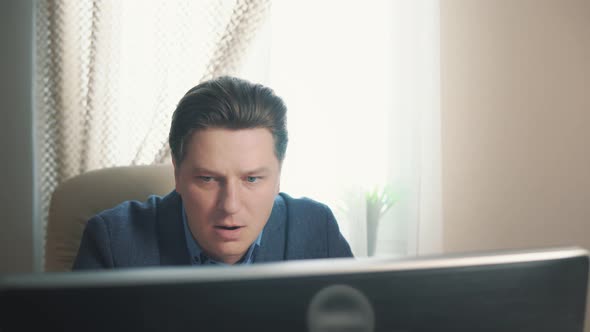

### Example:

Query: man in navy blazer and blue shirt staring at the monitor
xmin=73 ymin=77 xmax=352 ymax=269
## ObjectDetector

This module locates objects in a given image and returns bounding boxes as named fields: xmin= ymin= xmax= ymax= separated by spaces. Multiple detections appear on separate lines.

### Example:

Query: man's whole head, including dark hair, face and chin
xmin=169 ymin=77 xmax=287 ymax=264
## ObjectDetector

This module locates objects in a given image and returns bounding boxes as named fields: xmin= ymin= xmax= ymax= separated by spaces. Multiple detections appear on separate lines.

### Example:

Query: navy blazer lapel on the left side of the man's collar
xmin=156 ymin=191 xmax=190 ymax=265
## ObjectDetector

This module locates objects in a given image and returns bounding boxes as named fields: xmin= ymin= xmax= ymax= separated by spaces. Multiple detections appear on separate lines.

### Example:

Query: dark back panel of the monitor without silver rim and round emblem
xmin=0 ymin=257 xmax=588 ymax=332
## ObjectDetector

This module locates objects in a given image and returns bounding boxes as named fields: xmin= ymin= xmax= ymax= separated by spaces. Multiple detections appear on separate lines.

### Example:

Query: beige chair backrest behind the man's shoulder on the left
xmin=45 ymin=165 xmax=174 ymax=271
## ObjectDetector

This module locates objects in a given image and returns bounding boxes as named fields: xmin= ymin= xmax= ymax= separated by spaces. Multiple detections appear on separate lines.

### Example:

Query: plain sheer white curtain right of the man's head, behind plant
xmin=244 ymin=0 xmax=442 ymax=256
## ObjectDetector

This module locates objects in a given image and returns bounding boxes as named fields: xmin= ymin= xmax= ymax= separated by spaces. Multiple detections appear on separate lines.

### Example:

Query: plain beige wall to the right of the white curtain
xmin=441 ymin=0 xmax=590 ymax=331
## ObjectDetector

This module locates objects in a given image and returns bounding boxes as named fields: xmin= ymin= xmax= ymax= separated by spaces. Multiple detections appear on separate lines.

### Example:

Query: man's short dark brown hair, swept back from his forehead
xmin=168 ymin=76 xmax=288 ymax=165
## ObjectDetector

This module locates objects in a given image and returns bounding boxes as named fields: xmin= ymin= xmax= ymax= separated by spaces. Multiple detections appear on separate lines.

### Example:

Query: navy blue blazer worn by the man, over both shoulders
xmin=73 ymin=191 xmax=352 ymax=270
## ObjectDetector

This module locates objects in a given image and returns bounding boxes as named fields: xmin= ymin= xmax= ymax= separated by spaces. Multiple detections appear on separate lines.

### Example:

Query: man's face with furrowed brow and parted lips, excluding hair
xmin=174 ymin=128 xmax=280 ymax=264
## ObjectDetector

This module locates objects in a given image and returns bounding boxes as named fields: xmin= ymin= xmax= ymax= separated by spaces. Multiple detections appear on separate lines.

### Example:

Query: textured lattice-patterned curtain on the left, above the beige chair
xmin=36 ymin=0 xmax=269 ymax=266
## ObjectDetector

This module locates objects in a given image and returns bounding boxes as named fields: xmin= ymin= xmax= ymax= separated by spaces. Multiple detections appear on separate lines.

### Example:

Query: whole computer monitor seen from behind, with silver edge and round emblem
xmin=0 ymin=248 xmax=588 ymax=332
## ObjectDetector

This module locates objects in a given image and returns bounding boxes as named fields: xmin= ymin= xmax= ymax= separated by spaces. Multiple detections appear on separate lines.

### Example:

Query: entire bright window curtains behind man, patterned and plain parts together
xmin=37 ymin=0 xmax=442 ymax=256
